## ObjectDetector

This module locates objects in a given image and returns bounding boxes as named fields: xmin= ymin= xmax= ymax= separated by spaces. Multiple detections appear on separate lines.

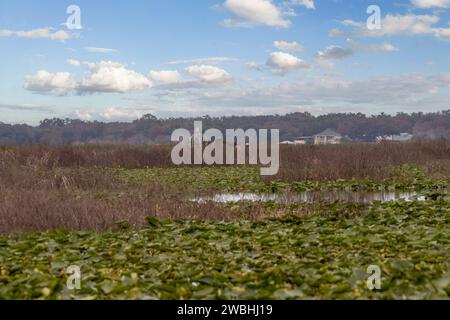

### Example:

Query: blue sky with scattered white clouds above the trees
xmin=0 ymin=0 xmax=450 ymax=124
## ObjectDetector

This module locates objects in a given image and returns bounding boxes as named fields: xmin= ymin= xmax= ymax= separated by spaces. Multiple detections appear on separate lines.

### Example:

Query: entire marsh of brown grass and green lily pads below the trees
xmin=0 ymin=141 xmax=450 ymax=300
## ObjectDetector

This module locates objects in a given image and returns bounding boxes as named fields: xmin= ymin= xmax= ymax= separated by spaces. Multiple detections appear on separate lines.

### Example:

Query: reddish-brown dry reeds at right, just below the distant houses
xmin=275 ymin=140 xmax=450 ymax=181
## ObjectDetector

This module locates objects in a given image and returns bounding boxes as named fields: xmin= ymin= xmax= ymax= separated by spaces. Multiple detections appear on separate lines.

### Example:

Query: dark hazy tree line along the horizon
xmin=0 ymin=110 xmax=450 ymax=145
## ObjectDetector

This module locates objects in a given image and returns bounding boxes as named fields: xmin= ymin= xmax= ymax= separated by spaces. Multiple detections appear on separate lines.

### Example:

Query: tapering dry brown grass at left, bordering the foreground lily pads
xmin=0 ymin=162 xmax=226 ymax=233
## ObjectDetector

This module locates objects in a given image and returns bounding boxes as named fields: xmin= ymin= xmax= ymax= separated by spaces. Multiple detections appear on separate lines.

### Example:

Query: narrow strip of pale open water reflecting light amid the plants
xmin=194 ymin=191 xmax=425 ymax=203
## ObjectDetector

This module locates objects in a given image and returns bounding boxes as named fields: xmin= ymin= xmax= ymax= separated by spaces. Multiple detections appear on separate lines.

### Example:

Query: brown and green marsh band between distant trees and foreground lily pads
xmin=0 ymin=141 xmax=450 ymax=233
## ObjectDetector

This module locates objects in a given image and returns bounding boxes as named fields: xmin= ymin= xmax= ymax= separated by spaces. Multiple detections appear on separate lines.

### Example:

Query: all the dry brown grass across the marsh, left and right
xmin=0 ymin=141 xmax=450 ymax=233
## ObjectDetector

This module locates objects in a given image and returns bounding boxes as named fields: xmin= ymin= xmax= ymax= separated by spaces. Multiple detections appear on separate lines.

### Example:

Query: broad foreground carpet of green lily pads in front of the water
xmin=0 ymin=199 xmax=450 ymax=299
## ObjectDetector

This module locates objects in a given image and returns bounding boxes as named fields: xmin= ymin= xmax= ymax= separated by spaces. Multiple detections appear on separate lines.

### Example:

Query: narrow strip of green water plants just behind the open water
xmin=114 ymin=166 xmax=450 ymax=193
